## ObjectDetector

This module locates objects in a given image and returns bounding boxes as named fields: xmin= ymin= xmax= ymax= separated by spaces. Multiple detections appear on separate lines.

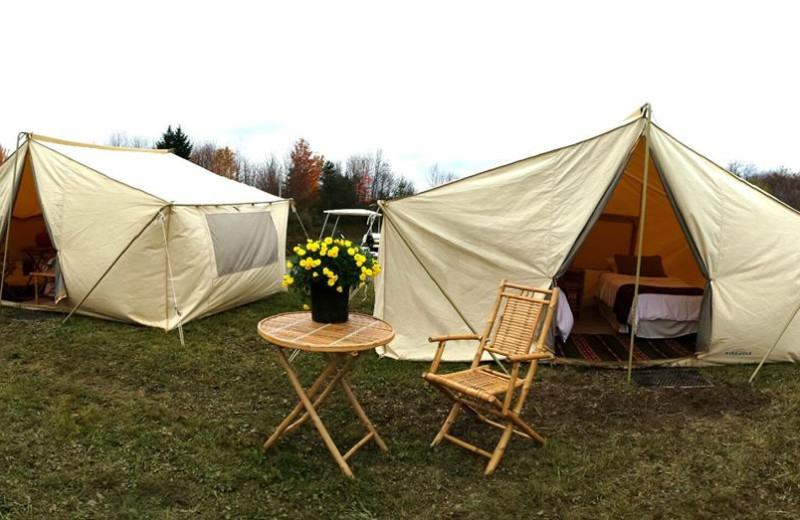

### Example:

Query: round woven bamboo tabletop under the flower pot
xmin=258 ymin=312 xmax=394 ymax=352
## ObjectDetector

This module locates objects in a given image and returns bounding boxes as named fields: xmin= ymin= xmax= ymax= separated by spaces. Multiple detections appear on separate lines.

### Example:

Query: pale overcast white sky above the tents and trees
xmin=0 ymin=0 xmax=800 ymax=187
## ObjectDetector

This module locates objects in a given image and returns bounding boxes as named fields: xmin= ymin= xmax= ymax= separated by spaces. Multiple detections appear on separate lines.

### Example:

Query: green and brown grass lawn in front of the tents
xmin=0 ymin=288 xmax=800 ymax=519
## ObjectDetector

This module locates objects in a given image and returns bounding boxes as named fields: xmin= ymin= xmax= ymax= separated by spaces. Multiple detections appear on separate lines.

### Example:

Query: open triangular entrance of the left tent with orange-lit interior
xmin=2 ymin=154 xmax=65 ymax=308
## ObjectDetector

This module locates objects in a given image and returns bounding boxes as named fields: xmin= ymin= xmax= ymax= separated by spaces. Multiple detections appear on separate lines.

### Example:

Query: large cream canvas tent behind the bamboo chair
xmin=375 ymin=107 xmax=800 ymax=364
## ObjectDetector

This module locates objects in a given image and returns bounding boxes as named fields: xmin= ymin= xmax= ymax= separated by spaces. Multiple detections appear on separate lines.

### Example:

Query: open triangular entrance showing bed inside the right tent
xmin=557 ymin=139 xmax=706 ymax=365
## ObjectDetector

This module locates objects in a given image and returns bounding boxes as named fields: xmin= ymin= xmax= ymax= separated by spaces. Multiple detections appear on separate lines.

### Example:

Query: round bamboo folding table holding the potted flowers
xmin=258 ymin=312 xmax=394 ymax=478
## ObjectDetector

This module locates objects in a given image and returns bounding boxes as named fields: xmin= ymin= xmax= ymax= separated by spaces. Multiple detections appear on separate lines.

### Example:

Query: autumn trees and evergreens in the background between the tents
xmin=108 ymin=125 xmax=415 ymax=213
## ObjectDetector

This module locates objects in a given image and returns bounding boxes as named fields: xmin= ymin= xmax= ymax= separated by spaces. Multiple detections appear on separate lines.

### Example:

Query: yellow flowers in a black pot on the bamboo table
xmin=283 ymin=237 xmax=381 ymax=323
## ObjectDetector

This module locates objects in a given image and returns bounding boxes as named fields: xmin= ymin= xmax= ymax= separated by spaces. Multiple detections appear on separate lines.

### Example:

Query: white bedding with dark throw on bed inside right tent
xmin=597 ymin=273 xmax=703 ymax=326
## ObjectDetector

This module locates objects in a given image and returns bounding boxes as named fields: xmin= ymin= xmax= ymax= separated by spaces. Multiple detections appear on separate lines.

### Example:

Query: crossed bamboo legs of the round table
xmin=264 ymin=347 xmax=388 ymax=478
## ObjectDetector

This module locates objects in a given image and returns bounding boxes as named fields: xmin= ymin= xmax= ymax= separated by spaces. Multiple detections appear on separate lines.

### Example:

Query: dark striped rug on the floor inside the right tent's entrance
xmin=556 ymin=334 xmax=697 ymax=366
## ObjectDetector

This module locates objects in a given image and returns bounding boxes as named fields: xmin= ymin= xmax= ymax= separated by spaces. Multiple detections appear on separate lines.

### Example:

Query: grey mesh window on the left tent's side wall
xmin=206 ymin=212 xmax=278 ymax=276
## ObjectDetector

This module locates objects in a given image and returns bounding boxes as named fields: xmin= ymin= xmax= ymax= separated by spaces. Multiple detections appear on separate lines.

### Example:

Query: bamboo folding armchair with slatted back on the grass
xmin=422 ymin=280 xmax=558 ymax=475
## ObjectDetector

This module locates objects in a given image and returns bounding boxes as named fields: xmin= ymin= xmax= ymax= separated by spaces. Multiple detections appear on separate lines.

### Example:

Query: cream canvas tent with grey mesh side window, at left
xmin=0 ymin=134 xmax=290 ymax=330
